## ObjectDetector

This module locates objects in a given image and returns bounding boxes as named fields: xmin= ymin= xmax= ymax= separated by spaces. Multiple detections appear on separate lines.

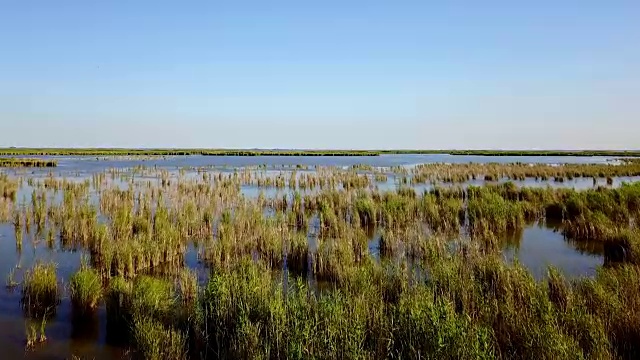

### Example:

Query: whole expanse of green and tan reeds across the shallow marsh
xmin=0 ymin=165 xmax=640 ymax=359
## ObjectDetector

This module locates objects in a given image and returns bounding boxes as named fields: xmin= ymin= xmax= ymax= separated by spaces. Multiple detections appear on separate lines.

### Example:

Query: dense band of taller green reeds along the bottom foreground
xmin=97 ymin=253 xmax=640 ymax=359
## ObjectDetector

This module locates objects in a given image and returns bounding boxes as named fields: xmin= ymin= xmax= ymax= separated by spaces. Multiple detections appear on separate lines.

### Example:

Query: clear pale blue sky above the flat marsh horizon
xmin=0 ymin=0 xmax=640 ymax=149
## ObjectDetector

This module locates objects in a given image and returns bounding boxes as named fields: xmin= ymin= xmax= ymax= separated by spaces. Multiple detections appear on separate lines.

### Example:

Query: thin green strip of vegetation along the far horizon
xmin=0 ymin=148 xmax=640 ymax=157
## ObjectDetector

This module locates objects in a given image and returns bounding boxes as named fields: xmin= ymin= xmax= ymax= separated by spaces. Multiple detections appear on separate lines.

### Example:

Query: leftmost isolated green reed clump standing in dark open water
xmin=21 ymin=262 xmax=60 ymax=314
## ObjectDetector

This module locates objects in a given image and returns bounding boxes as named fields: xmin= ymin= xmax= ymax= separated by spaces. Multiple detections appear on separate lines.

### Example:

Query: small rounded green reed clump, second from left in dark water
xmin=69 ymin=267 xmax=102 ymax=311
